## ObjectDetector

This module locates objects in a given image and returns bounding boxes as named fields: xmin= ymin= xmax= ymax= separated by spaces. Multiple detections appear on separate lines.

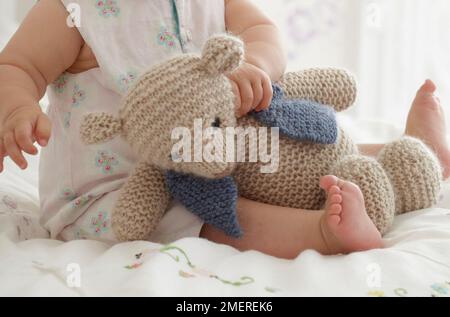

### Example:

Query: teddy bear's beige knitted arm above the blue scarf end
xmin=277 ymin=68 xmax=357 ymax=112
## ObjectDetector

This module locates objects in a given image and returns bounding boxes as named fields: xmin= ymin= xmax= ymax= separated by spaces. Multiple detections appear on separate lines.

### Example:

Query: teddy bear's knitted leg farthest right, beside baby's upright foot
xmin=378 ymin=137 xmax=442 ymax=214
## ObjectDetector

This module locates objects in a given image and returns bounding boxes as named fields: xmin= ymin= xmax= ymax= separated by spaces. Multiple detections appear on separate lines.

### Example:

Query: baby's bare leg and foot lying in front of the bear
xmin=201 ymin=176 xmax=382 ymax=258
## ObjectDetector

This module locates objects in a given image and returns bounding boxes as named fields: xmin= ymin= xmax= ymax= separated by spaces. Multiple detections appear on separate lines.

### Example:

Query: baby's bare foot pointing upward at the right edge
xmin=405 ymin=80 xmax=450 ymax=179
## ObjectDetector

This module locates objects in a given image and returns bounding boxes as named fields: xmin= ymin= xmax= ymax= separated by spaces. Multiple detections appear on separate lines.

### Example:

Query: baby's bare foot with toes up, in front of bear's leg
xmin=320 ymin=176 xmax=382 ymax=254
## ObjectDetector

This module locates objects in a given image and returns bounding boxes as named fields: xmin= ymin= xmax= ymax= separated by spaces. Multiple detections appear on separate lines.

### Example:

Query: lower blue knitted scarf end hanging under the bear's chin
xmin=166 ymin=172 xmax=242 ymax=238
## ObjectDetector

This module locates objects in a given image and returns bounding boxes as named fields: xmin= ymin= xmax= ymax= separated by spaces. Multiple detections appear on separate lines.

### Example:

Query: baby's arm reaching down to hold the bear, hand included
xmin=225 ymin=0 xmax=286 ymax=115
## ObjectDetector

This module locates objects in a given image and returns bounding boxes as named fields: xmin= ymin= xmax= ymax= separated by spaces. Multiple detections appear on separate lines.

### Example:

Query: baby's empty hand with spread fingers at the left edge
xmin=0 ymin=105 xmax=51 ymax=173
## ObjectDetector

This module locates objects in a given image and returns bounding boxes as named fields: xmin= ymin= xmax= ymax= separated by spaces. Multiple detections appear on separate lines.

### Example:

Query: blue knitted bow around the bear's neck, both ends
xmin=166 ymin=86 xmax=338 ymax=238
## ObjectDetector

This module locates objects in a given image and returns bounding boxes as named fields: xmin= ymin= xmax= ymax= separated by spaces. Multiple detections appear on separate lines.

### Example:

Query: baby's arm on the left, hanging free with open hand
xmin=0 ymin=0 xmax=84 ymax=172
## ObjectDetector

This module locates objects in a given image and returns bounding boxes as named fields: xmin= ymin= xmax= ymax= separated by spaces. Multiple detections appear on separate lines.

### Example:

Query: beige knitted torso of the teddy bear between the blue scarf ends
xmin=234 ymin=121 xmax=358 ymax=210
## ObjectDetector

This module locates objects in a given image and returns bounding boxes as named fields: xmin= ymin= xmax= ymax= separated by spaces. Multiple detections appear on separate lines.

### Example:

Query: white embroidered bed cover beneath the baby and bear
xmin=0 ymin=117 xmax=450 ymax=296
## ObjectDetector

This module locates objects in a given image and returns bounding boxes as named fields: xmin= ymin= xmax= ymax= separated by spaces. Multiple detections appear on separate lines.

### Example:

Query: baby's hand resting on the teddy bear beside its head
xmin=228 ymin=63 xmax=273 ymax=117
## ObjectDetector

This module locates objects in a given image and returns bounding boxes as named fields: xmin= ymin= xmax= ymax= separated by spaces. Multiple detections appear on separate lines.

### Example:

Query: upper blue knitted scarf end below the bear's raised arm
xmin=252 ymin=85 xmax=338 ymax=144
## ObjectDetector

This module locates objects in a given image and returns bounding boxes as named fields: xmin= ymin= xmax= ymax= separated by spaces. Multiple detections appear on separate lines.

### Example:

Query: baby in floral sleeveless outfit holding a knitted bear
xmin=0 ymin=0 xmax=450 ymax=258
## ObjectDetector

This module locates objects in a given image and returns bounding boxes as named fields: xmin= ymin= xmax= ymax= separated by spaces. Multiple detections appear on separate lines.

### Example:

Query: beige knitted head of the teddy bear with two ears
xmin=81 ymin=35 xmax=243 ymax=177
